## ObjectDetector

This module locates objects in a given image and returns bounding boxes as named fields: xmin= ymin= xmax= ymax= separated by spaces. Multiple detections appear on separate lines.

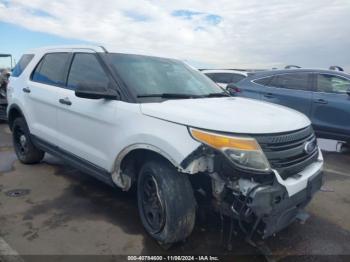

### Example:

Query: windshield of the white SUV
xmin=107 ymin=54 xmax=224 ymax=99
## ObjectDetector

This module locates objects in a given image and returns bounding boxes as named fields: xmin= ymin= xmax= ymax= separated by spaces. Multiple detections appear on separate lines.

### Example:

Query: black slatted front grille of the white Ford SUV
xmin=255 ymin=126 xmax=318 ymax=179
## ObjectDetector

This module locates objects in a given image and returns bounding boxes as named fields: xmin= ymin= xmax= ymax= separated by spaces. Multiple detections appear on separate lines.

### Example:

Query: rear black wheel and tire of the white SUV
xmin=12 ymin=117 xmax=45 ymax=164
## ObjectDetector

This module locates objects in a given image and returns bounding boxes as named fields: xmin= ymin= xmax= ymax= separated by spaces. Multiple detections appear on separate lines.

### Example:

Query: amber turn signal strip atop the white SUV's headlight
xmin=190 ymin=129 xmax=260 ymax=151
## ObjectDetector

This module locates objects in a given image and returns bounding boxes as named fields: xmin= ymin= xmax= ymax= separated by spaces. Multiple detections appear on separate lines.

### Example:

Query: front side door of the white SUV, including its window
xmin=57 ymin=51 xmax=118 ymax=169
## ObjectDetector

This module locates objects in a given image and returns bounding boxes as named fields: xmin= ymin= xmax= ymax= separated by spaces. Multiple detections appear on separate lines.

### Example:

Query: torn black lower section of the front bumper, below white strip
xmin=217 ymin=169 xmax=323 ymax=240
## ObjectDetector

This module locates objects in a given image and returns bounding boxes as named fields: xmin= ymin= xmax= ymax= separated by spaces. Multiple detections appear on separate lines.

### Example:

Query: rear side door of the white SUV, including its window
xmin=22 ymin=52 xmax=70 ymax=144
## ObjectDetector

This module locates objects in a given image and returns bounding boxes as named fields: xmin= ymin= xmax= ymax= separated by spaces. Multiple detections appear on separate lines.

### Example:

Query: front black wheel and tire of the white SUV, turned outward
xmin=137 ymin=160 xmax=196 ymax=245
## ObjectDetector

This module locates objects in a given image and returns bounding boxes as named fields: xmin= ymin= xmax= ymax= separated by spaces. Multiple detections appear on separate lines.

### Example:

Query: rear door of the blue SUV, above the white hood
xmin=261 ymin=72 xmax=313 ymax=116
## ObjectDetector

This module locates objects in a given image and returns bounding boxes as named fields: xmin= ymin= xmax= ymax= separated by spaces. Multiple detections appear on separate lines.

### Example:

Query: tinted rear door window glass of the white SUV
xmin=32 ymin=53 xmax=69 ymax=86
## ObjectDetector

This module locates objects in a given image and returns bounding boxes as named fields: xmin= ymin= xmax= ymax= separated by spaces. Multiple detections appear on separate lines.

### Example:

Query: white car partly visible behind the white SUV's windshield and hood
xmin=201 ymin=69 xmax=248 ymax=88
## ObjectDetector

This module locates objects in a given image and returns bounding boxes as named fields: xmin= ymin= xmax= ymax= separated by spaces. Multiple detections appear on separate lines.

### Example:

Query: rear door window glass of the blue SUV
xmin=269 ymin=73 xmax=311 ymax=91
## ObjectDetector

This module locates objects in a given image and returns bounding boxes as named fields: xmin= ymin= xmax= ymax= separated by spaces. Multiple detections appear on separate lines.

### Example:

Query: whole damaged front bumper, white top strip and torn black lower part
xmin=218 ymin=149 xmax=323 ymax=239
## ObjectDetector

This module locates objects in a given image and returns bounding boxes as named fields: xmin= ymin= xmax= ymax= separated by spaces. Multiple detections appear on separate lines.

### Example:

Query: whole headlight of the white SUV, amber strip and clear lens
xmin=190 ymin=128 xmax=270 ymax=172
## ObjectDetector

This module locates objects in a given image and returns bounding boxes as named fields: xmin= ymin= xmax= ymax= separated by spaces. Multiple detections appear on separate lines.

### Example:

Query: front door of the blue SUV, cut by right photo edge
xmin=311 ymin=74 xmax=350 ymax=141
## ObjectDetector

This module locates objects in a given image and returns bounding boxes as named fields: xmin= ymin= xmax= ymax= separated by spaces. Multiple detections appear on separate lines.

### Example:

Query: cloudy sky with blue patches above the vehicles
xmin=0 ymin=0 xmax=350 ymax=71
